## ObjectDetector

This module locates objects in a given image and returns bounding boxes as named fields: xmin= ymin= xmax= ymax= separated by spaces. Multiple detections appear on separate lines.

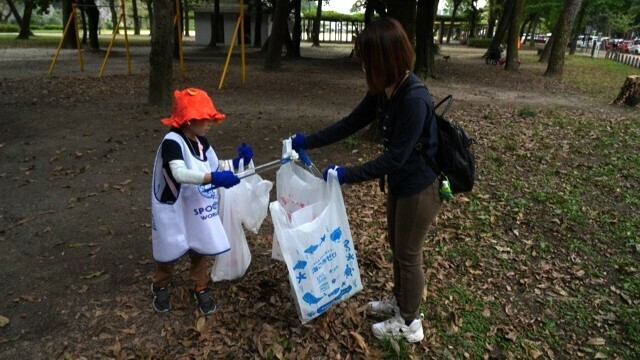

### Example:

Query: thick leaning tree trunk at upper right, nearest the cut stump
xmin=544 ymin=0 xmax=582 ymax=76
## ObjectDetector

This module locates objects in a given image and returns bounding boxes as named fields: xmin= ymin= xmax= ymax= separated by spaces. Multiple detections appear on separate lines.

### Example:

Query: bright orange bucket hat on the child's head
xmin=162 ymin=88 xmax=226 ymax=128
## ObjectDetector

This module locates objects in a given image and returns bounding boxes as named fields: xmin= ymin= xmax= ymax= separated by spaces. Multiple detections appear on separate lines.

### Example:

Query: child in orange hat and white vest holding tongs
xmin=151 ymin=88 xmax=253 ymax=315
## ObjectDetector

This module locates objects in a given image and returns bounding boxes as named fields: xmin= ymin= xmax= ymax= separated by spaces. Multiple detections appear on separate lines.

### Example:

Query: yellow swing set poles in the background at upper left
xmin=48 ymin=0 xmax=247 ymax=90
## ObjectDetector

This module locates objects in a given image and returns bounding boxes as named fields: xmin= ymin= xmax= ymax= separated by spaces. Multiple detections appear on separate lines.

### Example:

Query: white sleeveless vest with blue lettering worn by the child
xmin=151 ymin=132 xmax=229 ymax=262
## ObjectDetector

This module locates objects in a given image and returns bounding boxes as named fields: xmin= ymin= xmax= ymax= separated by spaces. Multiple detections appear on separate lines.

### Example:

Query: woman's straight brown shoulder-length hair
xmin=355 ymin=17 xmax=415 ymax=92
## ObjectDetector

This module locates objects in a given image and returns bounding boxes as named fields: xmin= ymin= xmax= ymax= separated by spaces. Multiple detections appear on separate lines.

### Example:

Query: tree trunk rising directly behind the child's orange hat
xmin=149 ymin=0 xmax=175 ymax=106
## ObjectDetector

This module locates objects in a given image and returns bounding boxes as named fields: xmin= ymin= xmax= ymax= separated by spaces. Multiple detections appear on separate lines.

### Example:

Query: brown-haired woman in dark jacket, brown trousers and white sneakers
xmin=292 ymin=17 xmax=442 ymax=342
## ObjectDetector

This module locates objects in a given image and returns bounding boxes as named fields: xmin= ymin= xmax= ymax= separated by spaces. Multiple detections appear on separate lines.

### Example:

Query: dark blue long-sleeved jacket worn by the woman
xmin=306 ymin=73 xmax=438 ymax=197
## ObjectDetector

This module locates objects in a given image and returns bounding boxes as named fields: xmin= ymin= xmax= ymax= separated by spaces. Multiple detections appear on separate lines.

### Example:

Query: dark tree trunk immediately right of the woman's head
xmin=413 ymin=0 xmax=438 ymax=79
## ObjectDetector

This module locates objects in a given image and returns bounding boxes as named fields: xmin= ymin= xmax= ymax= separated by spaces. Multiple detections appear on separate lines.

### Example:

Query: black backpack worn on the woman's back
xmin=403 ymin=84 xmax=476 ymax=194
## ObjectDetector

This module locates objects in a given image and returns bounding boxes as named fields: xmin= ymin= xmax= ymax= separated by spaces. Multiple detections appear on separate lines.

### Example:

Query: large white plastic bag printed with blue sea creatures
xmin=269 ymin=163 xmax=362 ymax=323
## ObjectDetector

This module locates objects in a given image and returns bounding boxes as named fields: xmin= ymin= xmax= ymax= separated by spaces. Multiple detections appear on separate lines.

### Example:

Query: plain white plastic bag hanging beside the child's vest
xmin=211 ymin=160 xmax=273 ymax=281
